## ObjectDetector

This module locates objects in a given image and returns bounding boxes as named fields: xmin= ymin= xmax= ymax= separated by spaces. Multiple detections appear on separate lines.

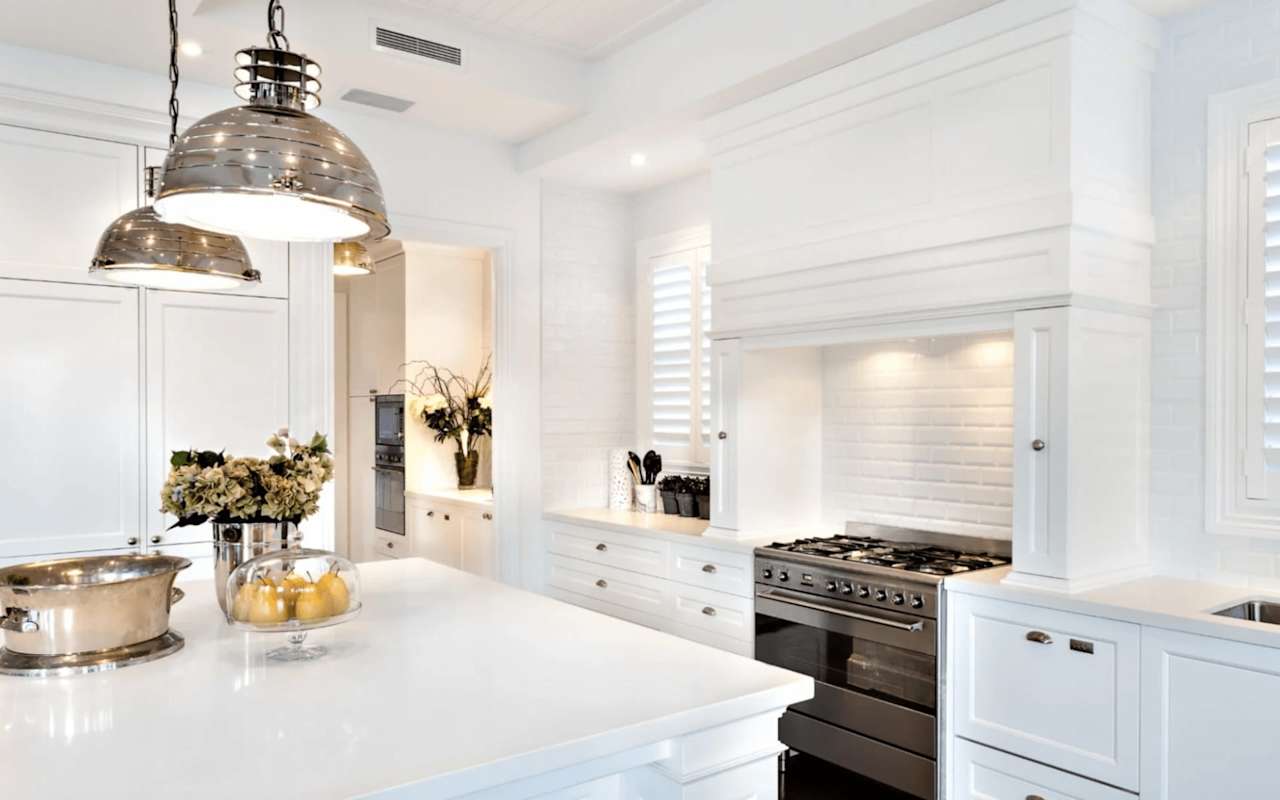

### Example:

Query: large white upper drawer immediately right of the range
xmin=948 ymin=594 xmax=1140 ymax=791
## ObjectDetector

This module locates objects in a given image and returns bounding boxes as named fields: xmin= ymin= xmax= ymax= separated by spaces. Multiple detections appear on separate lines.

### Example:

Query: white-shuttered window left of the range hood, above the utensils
xmin=637 ymin=230 xmax=712 ymax=467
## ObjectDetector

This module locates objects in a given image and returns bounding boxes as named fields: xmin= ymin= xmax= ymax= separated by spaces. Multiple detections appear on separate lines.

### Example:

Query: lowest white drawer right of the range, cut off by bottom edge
xmin=948 ymin=739 xmax=1134 ymax=800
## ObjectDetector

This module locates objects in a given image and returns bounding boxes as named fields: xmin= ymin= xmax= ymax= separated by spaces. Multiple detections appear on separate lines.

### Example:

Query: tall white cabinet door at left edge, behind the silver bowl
xmin=0 ymin=279 xmax=142 ymax=558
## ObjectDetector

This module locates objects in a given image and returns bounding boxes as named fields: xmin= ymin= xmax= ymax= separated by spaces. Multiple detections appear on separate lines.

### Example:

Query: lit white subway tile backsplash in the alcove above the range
xmin=822 ymin=334 xmax=1014 ymax=539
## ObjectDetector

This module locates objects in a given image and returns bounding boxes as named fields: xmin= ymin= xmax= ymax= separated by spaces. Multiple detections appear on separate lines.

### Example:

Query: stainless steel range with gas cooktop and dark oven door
xmin=755 ymin=522 xmax=1010 ymax=800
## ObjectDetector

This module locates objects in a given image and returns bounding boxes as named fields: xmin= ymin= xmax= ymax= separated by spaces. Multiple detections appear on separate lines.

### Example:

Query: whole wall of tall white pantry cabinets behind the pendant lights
xmin=0 ymin=124 xmax=293 ymax=576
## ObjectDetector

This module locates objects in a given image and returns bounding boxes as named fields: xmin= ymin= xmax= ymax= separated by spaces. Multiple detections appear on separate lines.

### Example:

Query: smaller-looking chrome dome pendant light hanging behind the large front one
xmin=88 ymin=0 xmax=261 ymax=289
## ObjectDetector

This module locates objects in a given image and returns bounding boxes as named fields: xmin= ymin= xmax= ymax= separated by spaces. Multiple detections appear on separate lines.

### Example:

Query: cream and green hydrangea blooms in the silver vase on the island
xmin=160 ymin=429 xmax=333 ymax=527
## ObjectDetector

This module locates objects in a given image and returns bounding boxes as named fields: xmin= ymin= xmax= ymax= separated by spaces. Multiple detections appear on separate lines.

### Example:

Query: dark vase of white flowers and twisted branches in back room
xmin=399 ymin=356 xmax=493 ymax=486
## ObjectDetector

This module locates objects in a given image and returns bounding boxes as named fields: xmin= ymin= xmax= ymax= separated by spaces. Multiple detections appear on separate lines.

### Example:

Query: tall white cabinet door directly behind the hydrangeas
xmin=146 ymin=292 xmax=289 ymax=545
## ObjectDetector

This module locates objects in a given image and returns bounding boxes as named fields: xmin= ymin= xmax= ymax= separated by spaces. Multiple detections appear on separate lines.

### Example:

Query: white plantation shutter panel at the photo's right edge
xmin=1243 ymin=120 xmax=1280 ymax=499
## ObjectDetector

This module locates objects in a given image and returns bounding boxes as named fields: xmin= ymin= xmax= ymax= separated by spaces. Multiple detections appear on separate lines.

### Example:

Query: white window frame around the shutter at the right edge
xmin=1204 ymin=81 xmax=1280 ymax=539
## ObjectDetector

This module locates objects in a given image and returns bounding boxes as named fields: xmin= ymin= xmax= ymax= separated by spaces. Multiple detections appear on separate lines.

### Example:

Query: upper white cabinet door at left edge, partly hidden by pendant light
xmin=0 ymin=125 xmax=141 ymax=283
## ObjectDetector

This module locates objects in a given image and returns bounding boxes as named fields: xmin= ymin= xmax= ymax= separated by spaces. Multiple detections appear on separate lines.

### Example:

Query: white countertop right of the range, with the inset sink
xmin=946 ymin=567 xmax=1280 ymax=648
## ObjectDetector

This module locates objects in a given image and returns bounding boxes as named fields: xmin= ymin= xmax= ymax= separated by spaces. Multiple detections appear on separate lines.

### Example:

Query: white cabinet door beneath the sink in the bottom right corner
xmin=1142 ymin=627 xmax=1280 ymax=800
